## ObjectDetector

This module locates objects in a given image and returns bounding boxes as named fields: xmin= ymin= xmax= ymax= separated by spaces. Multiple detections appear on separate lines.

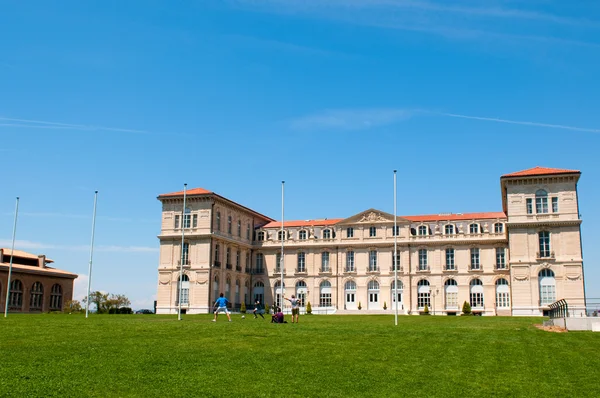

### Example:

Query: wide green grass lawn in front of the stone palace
xmin=0 ymin=314 xmax=600 ymax=397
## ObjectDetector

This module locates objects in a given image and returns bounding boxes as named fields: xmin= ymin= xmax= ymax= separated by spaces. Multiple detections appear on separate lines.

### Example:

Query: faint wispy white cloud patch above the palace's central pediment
xmin=290 ymin=108 xmax=416 ymax=130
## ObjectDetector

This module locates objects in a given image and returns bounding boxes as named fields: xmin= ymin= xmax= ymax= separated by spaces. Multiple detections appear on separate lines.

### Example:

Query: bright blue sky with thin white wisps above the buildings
xmin=0 ymin=0 xmax=600 ymax=308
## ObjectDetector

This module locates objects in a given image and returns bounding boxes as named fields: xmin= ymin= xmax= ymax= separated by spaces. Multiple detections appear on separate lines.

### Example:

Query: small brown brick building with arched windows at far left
xmin=0 ymin=248 xmax=77 ymax=312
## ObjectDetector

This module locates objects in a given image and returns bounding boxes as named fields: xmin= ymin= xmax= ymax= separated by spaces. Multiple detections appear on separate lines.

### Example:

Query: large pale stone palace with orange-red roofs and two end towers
xmin=157 ymin=167 xmax=585 ymax=316
